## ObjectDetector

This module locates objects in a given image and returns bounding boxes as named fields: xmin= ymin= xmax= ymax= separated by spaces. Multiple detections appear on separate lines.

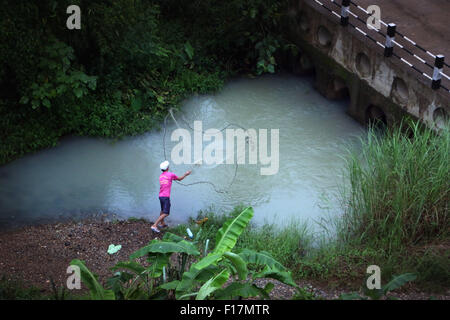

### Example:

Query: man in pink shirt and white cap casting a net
xmin=151 ymin=161 xmax=191 ymax=233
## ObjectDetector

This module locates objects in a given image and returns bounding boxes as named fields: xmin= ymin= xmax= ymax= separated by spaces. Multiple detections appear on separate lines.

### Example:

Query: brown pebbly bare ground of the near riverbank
xmin=0 ymin=220 xmax=450 ymax=300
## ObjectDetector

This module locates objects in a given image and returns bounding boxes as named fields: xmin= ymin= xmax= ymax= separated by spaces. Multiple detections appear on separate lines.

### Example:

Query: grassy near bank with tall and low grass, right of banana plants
xmin=173 ymin=122 xmax=450 ymax=291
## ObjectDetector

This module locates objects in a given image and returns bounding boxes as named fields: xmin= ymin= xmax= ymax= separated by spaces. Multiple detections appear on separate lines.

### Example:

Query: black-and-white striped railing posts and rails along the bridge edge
xmin=314 ymin=0 xmax=450 ymax=93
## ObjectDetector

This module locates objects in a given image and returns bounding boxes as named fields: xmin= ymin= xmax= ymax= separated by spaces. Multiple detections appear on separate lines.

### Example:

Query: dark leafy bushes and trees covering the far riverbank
xmin=0 ymin=0 xmax=292 ymax=164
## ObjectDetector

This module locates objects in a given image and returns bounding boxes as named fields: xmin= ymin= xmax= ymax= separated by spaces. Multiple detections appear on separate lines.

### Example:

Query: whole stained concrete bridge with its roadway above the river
xmin=283 ymin=0 xmax=450 ymax=128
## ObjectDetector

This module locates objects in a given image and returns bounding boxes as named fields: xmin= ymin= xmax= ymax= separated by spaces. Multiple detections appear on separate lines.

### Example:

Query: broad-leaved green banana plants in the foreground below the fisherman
xmin=71 ymin=208 xmax=297 ymax=300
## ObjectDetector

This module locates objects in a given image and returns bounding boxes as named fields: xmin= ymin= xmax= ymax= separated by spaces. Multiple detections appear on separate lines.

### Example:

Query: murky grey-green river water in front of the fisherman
xmin=0 ymin=75 xmax=365 ymax=227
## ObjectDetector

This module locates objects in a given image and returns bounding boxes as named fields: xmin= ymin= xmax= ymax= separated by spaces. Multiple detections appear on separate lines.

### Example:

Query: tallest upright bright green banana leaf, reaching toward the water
xmin=213 ymin=207 xmax=253 ymax=254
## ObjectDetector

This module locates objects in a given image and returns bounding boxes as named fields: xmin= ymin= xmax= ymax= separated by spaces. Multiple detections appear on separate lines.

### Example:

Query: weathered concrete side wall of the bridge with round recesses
xmin=285 ymin=0 xmax=450 ymax=127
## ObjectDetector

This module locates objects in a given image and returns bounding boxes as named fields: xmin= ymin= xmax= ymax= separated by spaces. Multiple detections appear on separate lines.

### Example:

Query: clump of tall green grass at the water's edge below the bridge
xmin=340 ymin=121 xmax=450 ymax=252
